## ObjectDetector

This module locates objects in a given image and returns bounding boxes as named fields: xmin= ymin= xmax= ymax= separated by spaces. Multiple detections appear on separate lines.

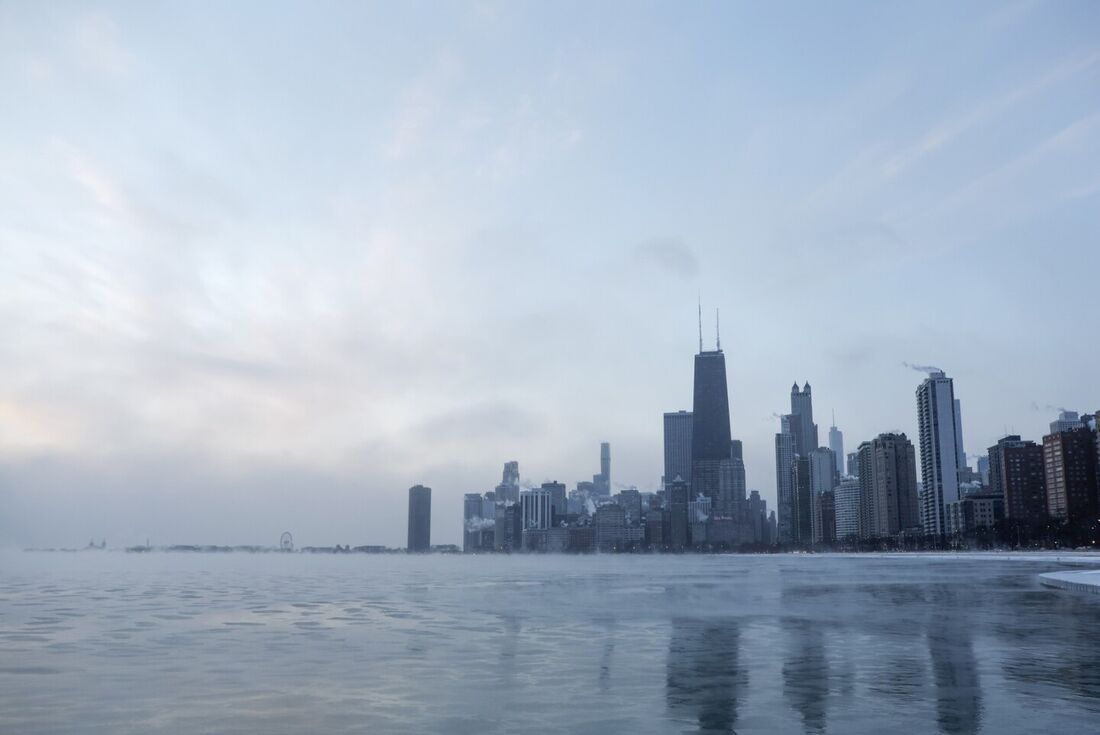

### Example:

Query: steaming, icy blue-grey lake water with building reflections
xmin=0 ymin=552 xmax=1100 ymax=735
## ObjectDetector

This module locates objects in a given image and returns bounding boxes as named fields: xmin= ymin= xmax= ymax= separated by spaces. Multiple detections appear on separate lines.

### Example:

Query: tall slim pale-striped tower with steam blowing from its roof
xmin=916 ymin=371 xmax=963 ymax=536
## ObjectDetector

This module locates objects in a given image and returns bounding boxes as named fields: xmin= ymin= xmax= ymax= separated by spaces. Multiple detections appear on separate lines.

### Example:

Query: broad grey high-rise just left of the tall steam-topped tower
xmin=868 ymin=434 xmax=921 ymax=537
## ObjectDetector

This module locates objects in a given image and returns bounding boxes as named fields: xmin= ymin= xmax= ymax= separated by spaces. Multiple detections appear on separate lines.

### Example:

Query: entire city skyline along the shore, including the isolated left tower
xmin=408 ymin=308 xmax=1100 ymax=552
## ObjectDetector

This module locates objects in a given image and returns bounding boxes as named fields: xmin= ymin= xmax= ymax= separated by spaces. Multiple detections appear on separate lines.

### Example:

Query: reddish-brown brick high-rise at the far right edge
xmin=1043 ymin=426 xmax=1098 ymax=525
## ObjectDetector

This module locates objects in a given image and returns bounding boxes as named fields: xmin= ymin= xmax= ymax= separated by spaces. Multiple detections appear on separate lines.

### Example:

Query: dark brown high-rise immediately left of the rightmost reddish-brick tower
xmin=989 ymin=435 xmax=1046 ymax=523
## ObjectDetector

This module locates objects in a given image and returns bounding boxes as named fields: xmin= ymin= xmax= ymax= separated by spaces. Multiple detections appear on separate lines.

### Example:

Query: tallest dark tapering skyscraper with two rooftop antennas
xmin=691 ymin=325 xmax=733 ymax=510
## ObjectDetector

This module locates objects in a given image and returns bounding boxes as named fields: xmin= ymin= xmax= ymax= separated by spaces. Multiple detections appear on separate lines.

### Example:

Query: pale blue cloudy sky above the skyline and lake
xmin=0 ymin=0 xmax=1100 ymax=547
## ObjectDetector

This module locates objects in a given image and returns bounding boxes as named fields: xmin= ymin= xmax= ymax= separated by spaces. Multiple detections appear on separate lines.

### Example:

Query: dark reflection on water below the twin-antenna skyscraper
xmin=666 ymin=617 xmax=748 ymax=733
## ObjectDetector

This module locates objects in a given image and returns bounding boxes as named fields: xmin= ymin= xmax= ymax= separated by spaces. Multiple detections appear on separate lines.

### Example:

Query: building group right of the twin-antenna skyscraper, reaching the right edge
xmin=776 ymin=370 xmax=1100 ymax=548
